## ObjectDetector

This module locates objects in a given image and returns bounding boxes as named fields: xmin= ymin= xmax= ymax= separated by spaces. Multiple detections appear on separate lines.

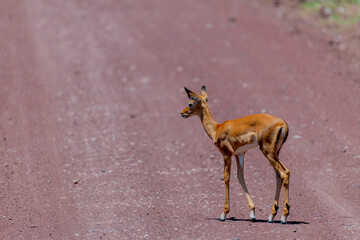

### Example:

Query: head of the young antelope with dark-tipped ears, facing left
xmin=180 ymin=86 xmax=208 ymax=118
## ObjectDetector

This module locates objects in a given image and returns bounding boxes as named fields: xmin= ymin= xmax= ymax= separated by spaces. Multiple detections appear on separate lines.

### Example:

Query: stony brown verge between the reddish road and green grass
xmin=268 ymin=0 xmax=360 ymax=72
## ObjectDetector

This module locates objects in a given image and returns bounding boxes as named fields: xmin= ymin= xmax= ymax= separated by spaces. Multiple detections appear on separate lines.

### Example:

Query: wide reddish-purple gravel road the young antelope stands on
xmin=0 ymin=0 xmax=360 ymax=239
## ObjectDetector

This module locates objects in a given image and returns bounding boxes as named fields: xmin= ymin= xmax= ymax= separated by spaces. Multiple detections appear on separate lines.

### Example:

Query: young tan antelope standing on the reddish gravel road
xmin=181 ymin=86 xmax=290 ymax=223
